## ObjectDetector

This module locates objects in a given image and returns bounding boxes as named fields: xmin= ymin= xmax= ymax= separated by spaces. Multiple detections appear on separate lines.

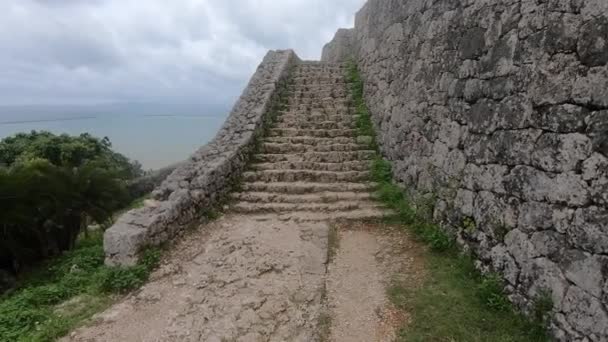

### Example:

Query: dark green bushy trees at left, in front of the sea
xmin=0 ymin=131 xmax=141 ymax=278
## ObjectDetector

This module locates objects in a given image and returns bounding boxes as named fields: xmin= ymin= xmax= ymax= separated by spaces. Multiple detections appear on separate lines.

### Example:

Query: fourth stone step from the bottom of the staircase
xmin=241 ymin=182 xmax=377 ymax=194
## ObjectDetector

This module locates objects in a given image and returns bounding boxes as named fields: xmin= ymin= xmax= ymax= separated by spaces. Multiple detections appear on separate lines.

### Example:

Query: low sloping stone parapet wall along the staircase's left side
xmin=104 ymin=50 xmax=299 ymax=265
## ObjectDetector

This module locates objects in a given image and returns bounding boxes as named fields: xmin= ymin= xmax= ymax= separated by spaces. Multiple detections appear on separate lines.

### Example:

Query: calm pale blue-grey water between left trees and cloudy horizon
xmin=0 ymin=105 xmax=227 ymax=169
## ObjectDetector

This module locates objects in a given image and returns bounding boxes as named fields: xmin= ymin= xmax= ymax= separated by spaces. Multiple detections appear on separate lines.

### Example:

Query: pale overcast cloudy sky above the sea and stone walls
xmin=0 ymin=0 xmax=364 ymax=105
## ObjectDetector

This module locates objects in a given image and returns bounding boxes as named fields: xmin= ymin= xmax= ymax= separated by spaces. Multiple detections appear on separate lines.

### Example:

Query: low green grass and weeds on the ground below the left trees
xmin=0 ymin=231 xmax=160 ymax=342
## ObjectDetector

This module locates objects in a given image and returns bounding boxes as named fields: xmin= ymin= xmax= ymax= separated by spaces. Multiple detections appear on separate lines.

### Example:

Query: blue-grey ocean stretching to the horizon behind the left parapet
xmin=0 ymin=104 xmax=230 ymax=169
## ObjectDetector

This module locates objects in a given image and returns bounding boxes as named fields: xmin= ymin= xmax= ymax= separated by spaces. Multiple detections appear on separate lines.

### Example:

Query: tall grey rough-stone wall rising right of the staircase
xmin=325 ymin=0 xmax=608 ymax=341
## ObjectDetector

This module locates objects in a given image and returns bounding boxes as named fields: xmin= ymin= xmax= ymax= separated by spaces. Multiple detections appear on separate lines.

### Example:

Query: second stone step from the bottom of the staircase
xmin=231 ymin=200 xmax=381 ymax=213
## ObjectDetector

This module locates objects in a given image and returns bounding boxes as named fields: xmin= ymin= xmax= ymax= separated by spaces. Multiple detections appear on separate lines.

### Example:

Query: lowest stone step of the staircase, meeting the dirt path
xmin=245 ymin=208 xmax=393 ymax=222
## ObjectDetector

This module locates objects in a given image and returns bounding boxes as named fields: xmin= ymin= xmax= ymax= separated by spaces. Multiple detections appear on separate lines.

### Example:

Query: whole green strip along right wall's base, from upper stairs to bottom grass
xmin=348 ymin=63 xmax=552 ymax=342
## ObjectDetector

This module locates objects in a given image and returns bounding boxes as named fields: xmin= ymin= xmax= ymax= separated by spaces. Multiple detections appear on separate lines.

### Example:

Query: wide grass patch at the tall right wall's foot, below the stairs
xmin=389 ymin=253 xmax=551 ymax=342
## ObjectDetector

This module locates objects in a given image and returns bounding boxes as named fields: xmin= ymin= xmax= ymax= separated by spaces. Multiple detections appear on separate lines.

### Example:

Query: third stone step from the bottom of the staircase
xmin=231 ymin=191 xmax=373 ymax=203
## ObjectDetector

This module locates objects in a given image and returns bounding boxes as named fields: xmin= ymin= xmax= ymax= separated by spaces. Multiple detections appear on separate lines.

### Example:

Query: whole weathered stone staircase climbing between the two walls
xmin=232 ymin=62 xmax=387 ymax=221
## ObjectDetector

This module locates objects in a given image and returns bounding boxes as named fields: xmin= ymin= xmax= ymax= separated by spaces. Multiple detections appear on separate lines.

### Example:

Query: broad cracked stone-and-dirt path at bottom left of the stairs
xmin=64 ymin=216 xmax=328 ymax=342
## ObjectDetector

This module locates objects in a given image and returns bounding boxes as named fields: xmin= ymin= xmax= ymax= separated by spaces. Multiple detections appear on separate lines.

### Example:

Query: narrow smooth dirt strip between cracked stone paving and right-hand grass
xmin=327 ymin=223 xmax=423 ymax=342
